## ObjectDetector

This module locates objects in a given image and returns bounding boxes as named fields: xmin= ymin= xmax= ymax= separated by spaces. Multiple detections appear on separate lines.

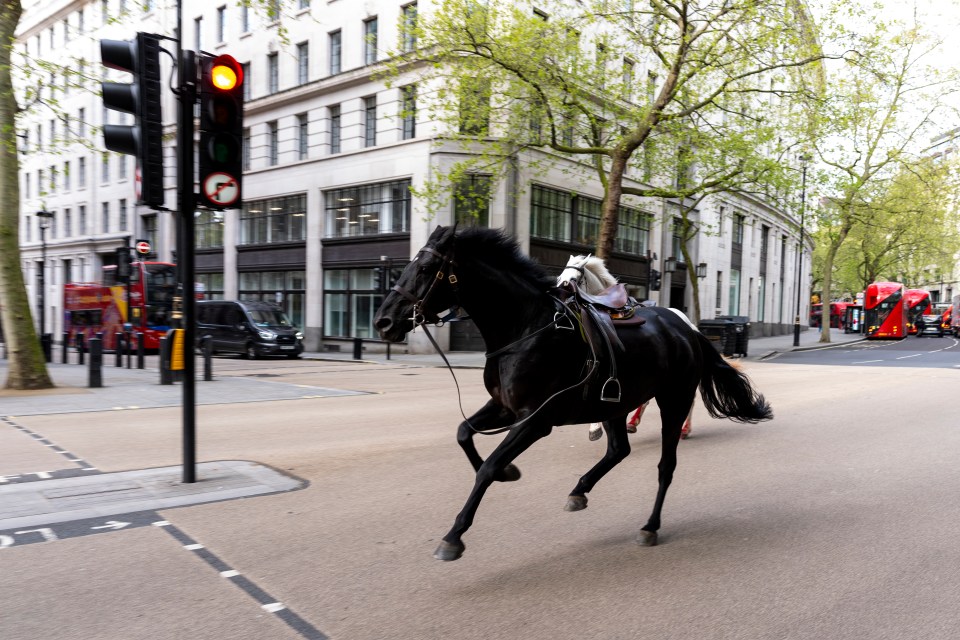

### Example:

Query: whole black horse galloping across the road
xmin=374 ymin=227 xmax=773 ymax=560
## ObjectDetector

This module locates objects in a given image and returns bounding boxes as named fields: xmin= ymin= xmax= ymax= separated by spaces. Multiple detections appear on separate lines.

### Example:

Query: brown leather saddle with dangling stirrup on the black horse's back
xmin=561 ymin=281 xmax=646 ymax=402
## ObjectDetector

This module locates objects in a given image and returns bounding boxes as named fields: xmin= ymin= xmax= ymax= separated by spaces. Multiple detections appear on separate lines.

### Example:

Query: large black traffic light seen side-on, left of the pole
xmin=100 ymin=33 xmax=163 ymax=207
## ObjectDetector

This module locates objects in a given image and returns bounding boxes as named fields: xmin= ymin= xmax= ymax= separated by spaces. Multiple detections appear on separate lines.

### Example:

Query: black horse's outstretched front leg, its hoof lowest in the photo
xmin=433 ymin=423 xmax=552 ymax=560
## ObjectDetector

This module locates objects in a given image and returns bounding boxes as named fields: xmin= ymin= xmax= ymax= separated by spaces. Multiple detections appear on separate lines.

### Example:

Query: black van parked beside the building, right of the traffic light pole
xmin=196 ymin=300 xmax=303 ymax=359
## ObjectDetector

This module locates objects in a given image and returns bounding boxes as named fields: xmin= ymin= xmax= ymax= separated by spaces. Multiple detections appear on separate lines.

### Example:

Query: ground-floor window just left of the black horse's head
xmin=323 ymin=265 xmax=401 ymax=338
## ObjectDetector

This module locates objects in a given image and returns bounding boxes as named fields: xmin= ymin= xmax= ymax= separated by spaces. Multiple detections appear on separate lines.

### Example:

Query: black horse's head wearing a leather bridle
xmin=373 ymin=227 xmax=457 ymax=342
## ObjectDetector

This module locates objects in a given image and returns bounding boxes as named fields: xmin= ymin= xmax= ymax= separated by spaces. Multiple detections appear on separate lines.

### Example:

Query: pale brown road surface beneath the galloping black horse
xmin=0 ymin=352 xmax=960 ymax=640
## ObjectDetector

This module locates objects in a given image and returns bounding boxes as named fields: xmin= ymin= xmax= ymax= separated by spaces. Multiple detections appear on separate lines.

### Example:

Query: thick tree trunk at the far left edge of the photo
xmin=0 ymin=0 xmax=53 ymax=389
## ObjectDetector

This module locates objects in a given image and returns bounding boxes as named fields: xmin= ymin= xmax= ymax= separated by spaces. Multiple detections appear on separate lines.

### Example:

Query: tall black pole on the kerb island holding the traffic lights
xmin=177 ymin=49 xmax=197 ymax=483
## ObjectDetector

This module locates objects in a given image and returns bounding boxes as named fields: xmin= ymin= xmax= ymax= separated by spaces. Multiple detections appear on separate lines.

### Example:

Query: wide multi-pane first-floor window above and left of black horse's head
xmin=324 ymin=180 xmax=410 ymax=238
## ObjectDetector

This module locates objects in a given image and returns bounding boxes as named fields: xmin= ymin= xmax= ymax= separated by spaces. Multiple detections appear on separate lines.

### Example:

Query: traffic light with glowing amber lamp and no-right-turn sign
xmin=199 ymin=54 xmax=244 ymax=209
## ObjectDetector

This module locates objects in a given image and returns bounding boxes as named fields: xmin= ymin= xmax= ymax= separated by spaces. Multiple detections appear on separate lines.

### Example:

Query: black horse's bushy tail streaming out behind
xmin=697 ymin=331 xmax=773 ymax=423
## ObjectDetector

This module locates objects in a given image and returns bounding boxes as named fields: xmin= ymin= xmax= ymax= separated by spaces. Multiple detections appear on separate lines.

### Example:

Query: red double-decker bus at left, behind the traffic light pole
xmin=63 ymin=262 xmax=177 ymax=350
